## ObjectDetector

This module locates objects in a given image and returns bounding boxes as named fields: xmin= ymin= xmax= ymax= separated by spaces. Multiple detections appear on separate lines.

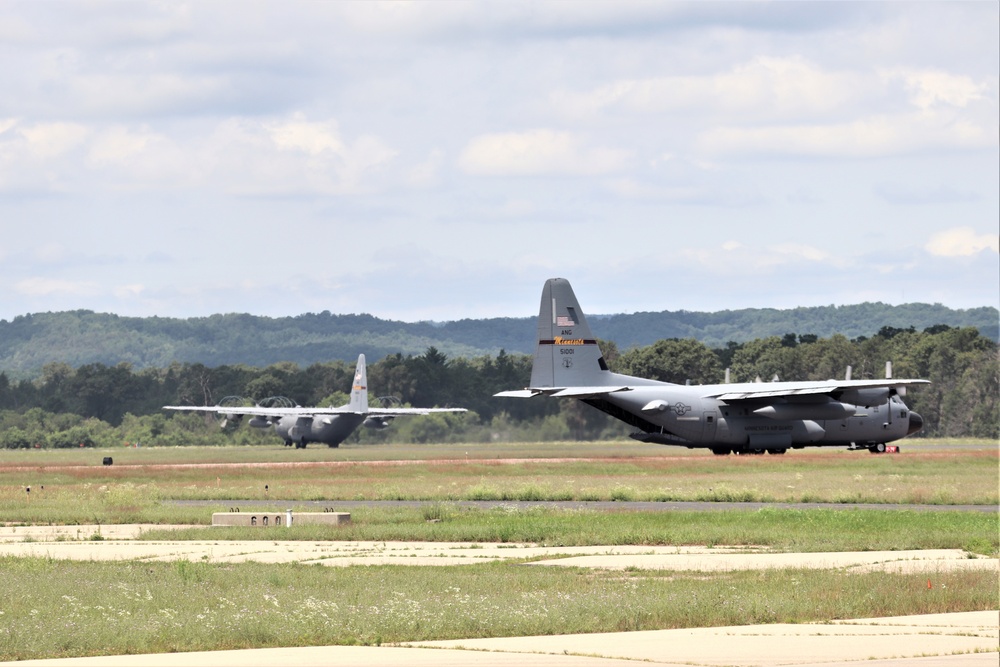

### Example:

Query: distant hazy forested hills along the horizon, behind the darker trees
xmin=0 ymin=303 xmax=1000 ymax=380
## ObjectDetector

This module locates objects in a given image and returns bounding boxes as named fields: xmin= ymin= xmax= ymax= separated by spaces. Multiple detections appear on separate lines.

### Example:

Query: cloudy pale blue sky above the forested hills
xmin=0 ymin=0 xmax=1000 ymax=322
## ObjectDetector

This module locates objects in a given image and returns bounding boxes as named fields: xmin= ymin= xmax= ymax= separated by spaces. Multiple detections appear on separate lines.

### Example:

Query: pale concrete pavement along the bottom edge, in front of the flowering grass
xmin=0 ymin=611 xmax=1000 ymax=667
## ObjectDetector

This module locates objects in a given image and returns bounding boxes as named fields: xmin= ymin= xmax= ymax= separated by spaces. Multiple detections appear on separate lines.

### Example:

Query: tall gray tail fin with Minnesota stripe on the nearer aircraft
xmin=531 ymin=278 xmax=611 ymax=389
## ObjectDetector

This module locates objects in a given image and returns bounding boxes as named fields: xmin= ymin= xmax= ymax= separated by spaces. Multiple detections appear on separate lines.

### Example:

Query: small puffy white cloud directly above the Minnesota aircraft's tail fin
xmin=458 ymin=129 xmax=628 ymax=176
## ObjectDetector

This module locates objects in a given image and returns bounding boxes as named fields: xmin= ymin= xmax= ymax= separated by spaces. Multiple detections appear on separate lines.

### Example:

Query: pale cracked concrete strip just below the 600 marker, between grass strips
xmin=0 ymin=526 xmax=1000 ymax=573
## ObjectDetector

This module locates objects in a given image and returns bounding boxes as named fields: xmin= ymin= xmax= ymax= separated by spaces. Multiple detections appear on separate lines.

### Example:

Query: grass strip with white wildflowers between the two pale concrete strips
xmin=0 ymin=559 xmax=997 ymax=660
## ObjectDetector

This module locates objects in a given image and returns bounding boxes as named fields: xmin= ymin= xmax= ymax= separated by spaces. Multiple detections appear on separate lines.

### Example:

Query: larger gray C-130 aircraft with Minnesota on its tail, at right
xmin=495 ymin=278 xmax=930 ymax=455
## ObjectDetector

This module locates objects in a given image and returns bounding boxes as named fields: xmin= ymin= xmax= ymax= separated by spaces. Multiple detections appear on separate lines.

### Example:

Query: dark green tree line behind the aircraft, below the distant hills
xmin=0 ymin=325 xmax=1000 ymax=448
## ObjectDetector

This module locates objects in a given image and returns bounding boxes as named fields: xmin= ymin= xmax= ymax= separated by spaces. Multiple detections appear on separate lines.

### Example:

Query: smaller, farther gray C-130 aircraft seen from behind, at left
xmin=163 ymin=354 xmax=466 ymax=449
